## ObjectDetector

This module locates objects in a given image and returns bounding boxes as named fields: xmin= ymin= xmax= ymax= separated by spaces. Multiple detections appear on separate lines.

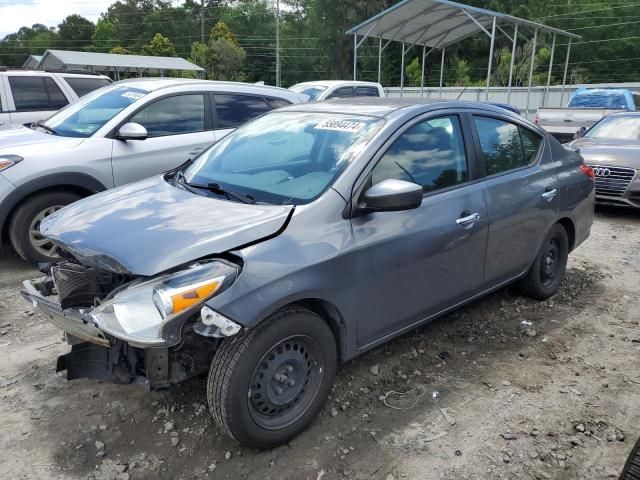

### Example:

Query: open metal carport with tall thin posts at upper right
xmin=346 ymin=0 xmax=581 ymax=109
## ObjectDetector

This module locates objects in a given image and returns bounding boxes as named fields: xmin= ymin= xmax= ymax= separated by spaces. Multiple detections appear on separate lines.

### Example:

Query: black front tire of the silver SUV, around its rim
xmin=9 ymin=191 xmax=82 ymax=263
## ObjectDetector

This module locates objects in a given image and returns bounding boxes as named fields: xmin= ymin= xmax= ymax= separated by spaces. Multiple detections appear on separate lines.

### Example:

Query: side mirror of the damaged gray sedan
xmin=364 ymin=179 xmax=423 ymax=212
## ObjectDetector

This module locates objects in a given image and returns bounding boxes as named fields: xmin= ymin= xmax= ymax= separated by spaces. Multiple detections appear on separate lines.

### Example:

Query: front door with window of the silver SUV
xmin=112 ymin=93 xmax=215 ymax=186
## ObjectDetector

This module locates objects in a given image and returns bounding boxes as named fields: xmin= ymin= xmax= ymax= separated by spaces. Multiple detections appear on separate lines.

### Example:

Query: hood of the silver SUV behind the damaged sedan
xmin=0 ymin=125 xmax=84 ymax=152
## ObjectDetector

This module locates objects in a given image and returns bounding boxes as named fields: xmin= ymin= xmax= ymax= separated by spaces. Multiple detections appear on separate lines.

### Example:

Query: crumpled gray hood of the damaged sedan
xmin=40 ymin=177 xmax=293 ymax=276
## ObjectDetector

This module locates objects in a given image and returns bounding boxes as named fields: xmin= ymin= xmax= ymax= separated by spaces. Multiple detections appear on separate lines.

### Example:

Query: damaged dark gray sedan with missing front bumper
xmin=22 ymin=100 xmax=594 ymax=448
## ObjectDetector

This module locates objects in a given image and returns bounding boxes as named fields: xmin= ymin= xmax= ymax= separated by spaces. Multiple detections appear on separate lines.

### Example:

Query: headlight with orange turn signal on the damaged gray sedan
xmin=90 ymin=260 xmax=239 ymax=346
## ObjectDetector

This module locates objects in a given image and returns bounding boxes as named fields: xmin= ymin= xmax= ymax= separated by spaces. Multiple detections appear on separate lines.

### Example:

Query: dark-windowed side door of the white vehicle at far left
xmin=5 ymin=73 xmax=69 ymax=125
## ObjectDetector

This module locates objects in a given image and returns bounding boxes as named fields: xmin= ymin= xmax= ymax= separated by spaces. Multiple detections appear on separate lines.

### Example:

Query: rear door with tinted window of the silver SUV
xmin=211 ymin=92 xmax=272 ymax=141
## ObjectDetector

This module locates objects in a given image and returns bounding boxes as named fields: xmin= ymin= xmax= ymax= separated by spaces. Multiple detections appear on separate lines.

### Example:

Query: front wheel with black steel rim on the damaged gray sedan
xmin=207 ymin=307 xmax=338 ymax=449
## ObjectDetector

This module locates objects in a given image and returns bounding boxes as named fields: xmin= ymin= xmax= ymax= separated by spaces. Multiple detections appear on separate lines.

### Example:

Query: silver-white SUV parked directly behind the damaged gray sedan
xmin=0 ymin=79 xmax=308 ymax=262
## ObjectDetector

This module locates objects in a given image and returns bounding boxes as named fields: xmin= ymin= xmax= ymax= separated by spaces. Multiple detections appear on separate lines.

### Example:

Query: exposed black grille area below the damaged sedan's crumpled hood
xmin=51 ymin=262 xmax=129 ymax=310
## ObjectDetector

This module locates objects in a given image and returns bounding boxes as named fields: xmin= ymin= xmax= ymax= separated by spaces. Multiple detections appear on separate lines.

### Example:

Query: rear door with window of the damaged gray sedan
xmin=471 ymin=113 xmax=560 ymax=286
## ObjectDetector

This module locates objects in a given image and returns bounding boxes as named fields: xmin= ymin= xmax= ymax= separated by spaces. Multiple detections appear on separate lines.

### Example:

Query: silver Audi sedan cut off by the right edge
xmin=569 ymin=112 xmax=640 ymax=208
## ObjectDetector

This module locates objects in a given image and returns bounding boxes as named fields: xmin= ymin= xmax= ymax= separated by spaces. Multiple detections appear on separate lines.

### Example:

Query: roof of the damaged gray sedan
xmin=279 ymin=97 xmax=533 ymax=119
